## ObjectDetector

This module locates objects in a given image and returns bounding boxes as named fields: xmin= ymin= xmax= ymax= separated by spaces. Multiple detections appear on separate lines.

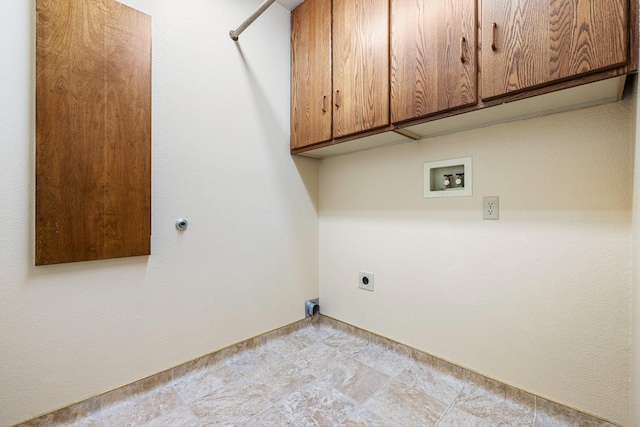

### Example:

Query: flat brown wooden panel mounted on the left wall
xmin=35 ymin=0 xmax=151 ymax=265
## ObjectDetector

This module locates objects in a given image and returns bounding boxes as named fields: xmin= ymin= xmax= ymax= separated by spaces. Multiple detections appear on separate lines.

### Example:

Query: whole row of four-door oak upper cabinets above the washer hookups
xmin=291 ymin=0 xmax=640 ymax=157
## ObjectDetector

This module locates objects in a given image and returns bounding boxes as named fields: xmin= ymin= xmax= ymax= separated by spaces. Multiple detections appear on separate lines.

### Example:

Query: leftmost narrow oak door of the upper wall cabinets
xmin=291 ymin=0 xmax=332 ymax=148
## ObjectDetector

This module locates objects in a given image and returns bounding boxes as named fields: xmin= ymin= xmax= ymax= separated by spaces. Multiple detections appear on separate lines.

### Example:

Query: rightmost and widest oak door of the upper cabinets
xmin=481 ymin=0 xmax=629 ymax=98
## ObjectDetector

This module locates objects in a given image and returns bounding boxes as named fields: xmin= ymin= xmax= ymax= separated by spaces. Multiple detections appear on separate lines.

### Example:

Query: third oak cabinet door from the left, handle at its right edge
xmin=391 ymin=0 xmax=478 ymax=123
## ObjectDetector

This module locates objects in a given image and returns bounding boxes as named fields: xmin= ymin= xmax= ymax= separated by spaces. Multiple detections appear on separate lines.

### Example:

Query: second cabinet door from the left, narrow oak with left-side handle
xmin=333 ymin=0 xmax=389 ymax=137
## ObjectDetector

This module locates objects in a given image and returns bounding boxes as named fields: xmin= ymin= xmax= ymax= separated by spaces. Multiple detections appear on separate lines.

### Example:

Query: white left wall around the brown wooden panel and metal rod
xmin=0 ymin=0 xmax=318 ymax=426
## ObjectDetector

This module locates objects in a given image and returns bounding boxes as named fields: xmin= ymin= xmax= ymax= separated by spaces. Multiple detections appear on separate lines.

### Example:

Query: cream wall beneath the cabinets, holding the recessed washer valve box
xmin=320 ymin=99 xmax=632 ymax=424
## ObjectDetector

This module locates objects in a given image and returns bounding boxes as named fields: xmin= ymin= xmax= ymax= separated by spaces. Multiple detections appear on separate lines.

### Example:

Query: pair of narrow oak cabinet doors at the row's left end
xmin=291 ymin=0 xmax=389 ymax=150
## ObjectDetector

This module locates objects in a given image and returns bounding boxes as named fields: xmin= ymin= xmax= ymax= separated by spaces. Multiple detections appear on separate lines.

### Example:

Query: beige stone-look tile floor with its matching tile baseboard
xmin=20 ymin=316 xmax=613 ymax=427
